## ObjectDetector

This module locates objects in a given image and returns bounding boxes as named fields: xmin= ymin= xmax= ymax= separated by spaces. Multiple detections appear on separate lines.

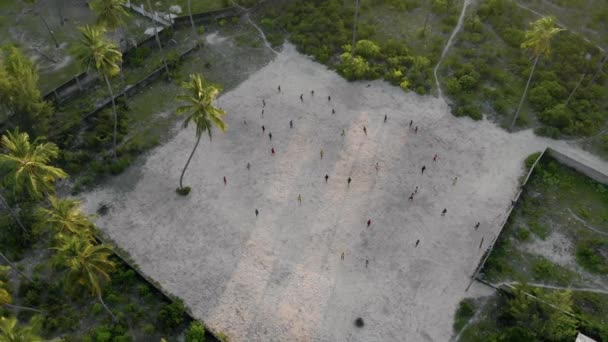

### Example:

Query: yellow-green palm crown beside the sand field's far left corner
xmin=37 ymin=196 xmax=95 ymax=236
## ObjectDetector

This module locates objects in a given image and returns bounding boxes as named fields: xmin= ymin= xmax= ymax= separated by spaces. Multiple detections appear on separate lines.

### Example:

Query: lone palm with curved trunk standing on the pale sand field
xmin=177 ymin=74 xmax=226 ymax=194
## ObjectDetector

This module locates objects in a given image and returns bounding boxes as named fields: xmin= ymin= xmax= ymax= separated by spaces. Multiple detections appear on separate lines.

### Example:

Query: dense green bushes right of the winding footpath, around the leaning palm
xmin=442 ymin=0 xmax=608 ymax=138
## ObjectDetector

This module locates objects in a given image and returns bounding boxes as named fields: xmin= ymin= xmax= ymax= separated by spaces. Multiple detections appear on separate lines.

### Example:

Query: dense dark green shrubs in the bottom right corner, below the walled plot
xmin=454 ymin=285 xmax=608 ymax=342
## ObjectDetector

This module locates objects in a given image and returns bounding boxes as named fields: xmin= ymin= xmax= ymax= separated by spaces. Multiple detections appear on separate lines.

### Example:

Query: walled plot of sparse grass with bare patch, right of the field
xmin=482 ymin=155 xmax=608 ymax=287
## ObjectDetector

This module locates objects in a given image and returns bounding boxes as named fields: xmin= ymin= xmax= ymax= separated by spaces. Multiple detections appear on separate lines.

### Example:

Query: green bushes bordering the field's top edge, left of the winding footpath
xmin=261 ymin=0 xmax=458 ymax=94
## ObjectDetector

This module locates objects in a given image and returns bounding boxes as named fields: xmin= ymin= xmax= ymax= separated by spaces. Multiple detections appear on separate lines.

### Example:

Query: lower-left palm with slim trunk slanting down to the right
xmin=53 ymin=235 xmax=116 ymax=320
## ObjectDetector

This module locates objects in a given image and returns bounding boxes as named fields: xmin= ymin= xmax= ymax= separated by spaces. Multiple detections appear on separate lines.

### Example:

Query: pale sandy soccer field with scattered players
xmin=85 ymin=45 xmax=606 ymax=342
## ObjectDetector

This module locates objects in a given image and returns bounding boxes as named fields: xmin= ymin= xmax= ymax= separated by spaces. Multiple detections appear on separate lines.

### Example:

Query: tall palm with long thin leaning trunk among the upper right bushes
xmin=509 ymin=17 xmax=563 ymax=131
